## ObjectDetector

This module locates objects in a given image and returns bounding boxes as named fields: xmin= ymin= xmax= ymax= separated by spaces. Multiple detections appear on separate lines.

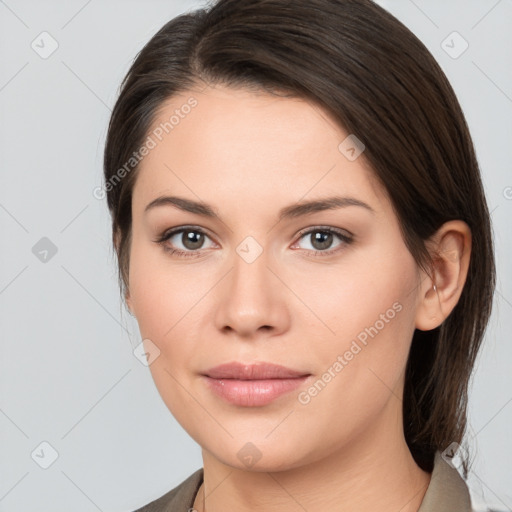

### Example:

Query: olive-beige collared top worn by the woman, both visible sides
xmin=135 ymin=452 xmax=471 ymax=512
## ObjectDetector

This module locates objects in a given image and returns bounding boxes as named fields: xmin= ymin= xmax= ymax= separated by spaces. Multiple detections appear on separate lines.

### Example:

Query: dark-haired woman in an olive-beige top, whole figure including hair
xmin=101 ymin=0 xmax=495 ymax=512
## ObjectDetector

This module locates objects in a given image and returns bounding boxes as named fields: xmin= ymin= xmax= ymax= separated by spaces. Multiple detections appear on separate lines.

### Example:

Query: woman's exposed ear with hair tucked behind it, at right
xmin=416 ymin=220 xmax=471 ymax=331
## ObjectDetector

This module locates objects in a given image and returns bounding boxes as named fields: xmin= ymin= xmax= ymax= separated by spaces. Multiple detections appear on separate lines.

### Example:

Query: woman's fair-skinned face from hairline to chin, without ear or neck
xmin=128 ymin=87 xmax=420 ymax=471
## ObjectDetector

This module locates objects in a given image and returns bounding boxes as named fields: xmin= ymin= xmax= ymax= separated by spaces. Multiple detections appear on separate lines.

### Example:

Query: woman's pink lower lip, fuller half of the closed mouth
xmin=204 ymin=375 xmax=309 ymax=407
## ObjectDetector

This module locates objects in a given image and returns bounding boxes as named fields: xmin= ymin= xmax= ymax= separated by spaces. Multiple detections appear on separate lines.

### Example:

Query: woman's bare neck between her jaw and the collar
xmin=194 ymin=402 xmax=430 ymax=512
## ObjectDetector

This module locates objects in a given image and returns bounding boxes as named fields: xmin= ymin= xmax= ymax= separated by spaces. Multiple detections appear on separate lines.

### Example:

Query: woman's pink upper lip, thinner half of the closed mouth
xmin=204 ymin=361 xmax=310 ymax=380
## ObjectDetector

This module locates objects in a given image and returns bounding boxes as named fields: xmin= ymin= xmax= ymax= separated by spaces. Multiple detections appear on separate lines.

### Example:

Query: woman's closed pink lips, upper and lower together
xmin=203 ymin=362 xmax=310 ymax=407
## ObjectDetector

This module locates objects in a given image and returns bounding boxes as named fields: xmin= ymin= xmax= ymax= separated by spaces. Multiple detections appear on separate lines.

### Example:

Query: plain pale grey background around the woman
xmin=0 ymin=0 xmax=512 ymax=512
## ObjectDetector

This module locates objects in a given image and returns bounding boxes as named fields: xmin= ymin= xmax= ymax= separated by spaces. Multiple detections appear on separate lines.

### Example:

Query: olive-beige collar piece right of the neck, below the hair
xmin=418 ymin=452 xmax=472 ymax=512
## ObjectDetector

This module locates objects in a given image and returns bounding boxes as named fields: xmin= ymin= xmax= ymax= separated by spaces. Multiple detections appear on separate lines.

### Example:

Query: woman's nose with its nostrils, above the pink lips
xmin=215 ymin=244 xmax=290 ymax=339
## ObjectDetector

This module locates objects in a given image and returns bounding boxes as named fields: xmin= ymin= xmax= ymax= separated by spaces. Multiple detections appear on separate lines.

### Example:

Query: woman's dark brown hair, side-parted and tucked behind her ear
xmin=104 ymin=0 xmax=495 ymax=471
